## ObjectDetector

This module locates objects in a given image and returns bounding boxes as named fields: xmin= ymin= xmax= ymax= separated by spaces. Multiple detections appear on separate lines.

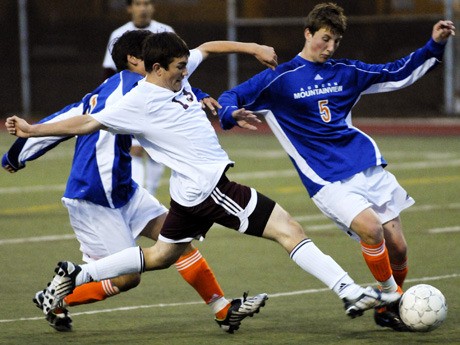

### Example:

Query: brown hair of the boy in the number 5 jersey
xmin=304 ymin=2 xmax=347 ymax=35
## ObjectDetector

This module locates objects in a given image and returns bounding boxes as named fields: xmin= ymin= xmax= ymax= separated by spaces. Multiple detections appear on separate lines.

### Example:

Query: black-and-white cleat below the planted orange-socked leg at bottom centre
xmin=215 ymin=292 xmax=268 ymax=333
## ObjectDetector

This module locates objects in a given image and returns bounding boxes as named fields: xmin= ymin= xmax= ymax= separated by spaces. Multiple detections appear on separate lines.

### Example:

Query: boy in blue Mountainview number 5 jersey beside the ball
xmin=219 ymin=3 xmax=455 ymax=330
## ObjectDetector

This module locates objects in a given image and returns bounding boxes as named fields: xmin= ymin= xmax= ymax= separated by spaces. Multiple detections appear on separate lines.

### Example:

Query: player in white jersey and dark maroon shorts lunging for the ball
xmin=5 ymin=33 xmax=400 ymax=330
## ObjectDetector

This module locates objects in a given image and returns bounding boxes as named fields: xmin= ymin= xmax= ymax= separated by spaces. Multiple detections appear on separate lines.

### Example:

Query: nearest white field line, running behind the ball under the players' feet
xmin=0 ymin=273 xmax=460 ymax=323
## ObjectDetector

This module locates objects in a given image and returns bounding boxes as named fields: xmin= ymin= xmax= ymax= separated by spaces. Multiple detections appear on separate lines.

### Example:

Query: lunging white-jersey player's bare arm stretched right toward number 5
xmin=197 ymin=41 xmax=278 ymax=69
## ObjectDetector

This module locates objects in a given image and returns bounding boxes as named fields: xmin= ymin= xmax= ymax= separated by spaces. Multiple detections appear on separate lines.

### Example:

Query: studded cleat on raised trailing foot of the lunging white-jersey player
xmin=42 ymin=261 xmax=81 ymax=315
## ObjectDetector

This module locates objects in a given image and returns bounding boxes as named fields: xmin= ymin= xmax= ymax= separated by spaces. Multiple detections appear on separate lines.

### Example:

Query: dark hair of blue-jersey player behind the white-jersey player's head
xmin=112 ymin=30 xmax=152 ymax=71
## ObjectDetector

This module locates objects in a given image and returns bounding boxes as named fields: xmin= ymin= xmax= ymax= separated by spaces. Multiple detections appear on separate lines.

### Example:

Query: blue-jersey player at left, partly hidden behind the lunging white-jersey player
xmin=2 ymin=30 xmax=274 ymax=332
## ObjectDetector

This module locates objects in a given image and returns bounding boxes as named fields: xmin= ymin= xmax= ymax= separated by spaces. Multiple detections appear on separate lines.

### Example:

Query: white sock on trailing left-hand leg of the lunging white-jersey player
xmin=75 ymin=247 xmax=144 ymax=286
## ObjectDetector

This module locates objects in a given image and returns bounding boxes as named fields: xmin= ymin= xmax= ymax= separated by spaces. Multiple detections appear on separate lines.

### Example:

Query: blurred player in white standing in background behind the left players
xmin=102 ymin=0 xmax=174 ymax=195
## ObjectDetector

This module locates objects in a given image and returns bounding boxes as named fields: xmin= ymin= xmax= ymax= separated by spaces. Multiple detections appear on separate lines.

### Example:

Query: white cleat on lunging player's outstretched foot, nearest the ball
xmin=343 ymin=286 xmax=401 ymax=319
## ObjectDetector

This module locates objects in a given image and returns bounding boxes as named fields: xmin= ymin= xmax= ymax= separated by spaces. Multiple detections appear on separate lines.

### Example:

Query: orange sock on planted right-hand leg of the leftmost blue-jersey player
xmin=176 ymin=248 xmax=229 ymax=315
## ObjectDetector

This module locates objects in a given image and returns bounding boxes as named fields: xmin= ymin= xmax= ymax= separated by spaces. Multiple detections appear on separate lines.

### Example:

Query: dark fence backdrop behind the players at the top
xmin=0 ymin=0 xmax=460 ymax=117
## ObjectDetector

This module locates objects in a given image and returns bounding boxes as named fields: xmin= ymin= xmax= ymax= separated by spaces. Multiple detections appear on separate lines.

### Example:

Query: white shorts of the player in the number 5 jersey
xmin=312 ymin=166 xmax=415 ymax=240
